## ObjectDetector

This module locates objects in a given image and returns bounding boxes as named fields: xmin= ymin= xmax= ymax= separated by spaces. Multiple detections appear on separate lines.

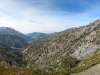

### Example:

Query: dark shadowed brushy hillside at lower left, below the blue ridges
xmin=0 ymin=46 xmax=26 ymax=67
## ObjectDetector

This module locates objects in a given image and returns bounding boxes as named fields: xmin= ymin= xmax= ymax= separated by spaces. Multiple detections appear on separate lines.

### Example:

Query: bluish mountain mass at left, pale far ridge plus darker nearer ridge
xmin=0 ymin=27 xmax=29 ymax=49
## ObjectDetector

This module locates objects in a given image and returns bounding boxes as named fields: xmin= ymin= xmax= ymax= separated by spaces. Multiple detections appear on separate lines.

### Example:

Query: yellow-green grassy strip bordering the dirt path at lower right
xmin=69 ymin=53 xmax=100 ymax=73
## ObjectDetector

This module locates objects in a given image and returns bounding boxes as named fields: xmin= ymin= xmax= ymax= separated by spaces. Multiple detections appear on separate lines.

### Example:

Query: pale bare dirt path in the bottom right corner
xmin=73 ymin=64 xmax=100 ymax=75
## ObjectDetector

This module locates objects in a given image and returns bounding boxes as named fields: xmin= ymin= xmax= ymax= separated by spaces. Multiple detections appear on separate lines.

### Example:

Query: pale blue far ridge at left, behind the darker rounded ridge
xmin=0 ymin=27 xmax=32 ymax=41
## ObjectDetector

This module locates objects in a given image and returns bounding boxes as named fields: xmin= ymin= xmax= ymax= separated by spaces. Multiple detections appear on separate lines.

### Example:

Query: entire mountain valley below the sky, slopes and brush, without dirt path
xmin=0 ymin=20 xmax=100 ymax=75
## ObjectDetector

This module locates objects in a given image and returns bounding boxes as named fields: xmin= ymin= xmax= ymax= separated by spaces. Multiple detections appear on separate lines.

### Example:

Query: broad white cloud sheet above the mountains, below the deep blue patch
xmin=0 ymin=0 xmax=100 ymax=33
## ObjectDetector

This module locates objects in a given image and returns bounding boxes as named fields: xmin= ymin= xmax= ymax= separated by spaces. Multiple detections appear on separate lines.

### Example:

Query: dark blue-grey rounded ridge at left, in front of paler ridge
xmin=0 ymin=34 xmax=28 ymax=49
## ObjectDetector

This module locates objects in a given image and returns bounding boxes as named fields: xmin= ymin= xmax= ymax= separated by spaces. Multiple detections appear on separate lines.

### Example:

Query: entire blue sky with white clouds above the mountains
xmin=0 ymin=0 xmax=100 ymax=34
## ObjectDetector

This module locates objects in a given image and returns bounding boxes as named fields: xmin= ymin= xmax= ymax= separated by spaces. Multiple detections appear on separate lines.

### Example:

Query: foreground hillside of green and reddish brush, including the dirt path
xmin=0 ymin=48 xmax=100 ymax=75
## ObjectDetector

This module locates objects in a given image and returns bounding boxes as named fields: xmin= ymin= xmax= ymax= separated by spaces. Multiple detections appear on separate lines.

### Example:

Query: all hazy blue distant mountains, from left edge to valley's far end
xmin=0 ymin=27 xmax=47 ymax=49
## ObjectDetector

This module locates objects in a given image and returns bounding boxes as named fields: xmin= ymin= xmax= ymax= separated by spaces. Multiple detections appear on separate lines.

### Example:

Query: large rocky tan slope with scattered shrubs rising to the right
xmin=23 ymin=20 xmax=100 ymax=71
